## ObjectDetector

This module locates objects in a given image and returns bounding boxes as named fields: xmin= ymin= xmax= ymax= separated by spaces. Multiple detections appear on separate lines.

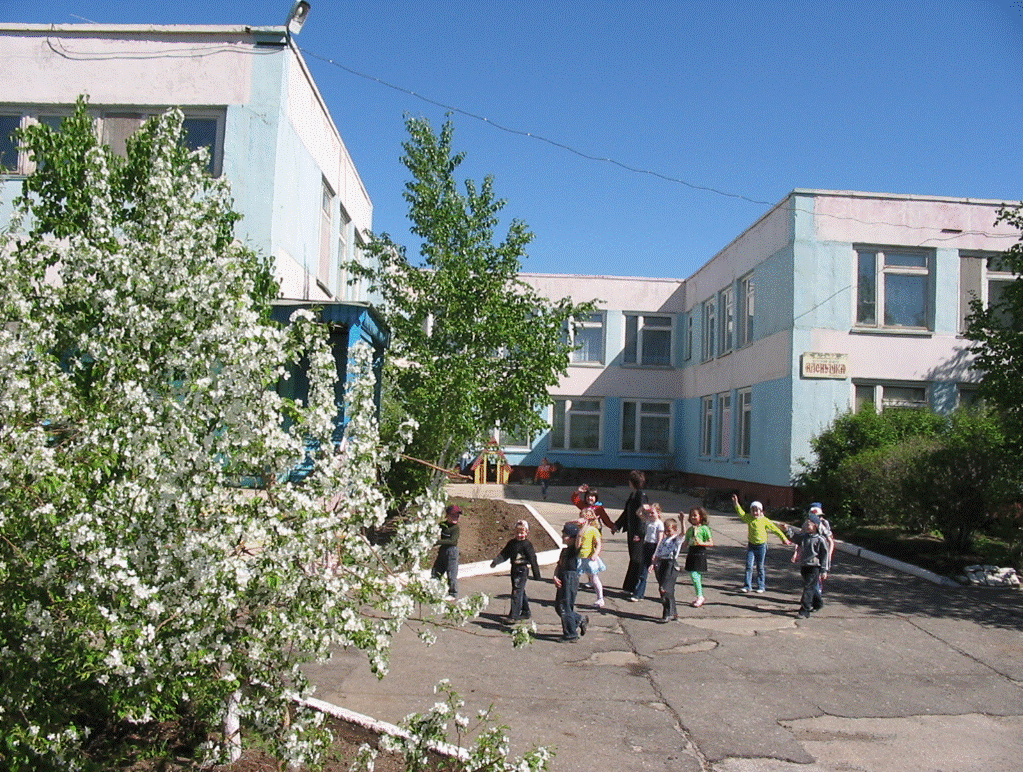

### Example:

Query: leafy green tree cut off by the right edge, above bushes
xmin=966 ymin=205 xmax=1023 ymax=453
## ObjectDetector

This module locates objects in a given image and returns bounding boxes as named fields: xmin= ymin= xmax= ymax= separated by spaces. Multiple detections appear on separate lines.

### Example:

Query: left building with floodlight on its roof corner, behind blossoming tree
xmin=0 ymin=25 xmax=388 ymax=429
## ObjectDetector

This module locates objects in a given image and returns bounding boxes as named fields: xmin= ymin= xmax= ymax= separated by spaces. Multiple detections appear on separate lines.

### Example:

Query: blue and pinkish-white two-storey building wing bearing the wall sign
xmin=515 ymin=190 xmax=1019 ymax=506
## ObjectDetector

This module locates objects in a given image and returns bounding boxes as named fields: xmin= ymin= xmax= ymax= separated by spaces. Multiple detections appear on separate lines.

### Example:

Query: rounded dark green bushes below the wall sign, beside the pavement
xmin=797 ymin=408 xmax=1023 ymax=554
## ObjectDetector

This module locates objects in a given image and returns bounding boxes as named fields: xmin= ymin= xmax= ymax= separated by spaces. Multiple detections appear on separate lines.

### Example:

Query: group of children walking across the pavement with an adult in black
xmin=434 ymin=472 xmax=835 ymax=640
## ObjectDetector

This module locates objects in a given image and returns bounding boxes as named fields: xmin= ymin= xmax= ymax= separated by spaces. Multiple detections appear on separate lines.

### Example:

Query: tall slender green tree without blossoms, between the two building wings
xmin=349 ymin=118 xmax=591 ymax=493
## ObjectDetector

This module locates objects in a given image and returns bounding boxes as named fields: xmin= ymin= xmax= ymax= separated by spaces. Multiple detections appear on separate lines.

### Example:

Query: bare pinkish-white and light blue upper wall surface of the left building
xmin=0 ymin=25 xmax=372 ymax=300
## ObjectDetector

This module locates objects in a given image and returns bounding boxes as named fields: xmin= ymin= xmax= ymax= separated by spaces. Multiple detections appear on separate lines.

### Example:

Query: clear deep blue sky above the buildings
xmin=7 ymin=0 xmax=1023 ymax=278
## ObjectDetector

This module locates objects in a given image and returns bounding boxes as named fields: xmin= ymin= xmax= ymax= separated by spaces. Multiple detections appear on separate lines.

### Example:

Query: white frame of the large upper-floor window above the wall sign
xmin=854 ymin=246 xmax=934 ymax=330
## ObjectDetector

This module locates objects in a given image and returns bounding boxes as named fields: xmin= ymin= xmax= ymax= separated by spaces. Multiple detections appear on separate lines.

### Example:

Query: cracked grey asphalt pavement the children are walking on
xmin=310 ymin=485 xmax=1023 ymax=772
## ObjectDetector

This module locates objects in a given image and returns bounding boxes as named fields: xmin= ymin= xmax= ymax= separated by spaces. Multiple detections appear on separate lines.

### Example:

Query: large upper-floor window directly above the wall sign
xmin=856 ymin=249 xmax=931 ymax=329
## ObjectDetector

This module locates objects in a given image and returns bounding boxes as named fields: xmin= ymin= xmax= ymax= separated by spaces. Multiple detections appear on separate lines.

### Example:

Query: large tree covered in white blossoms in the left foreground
xmin=0 ymin=102 xmax=507 ymax=770
